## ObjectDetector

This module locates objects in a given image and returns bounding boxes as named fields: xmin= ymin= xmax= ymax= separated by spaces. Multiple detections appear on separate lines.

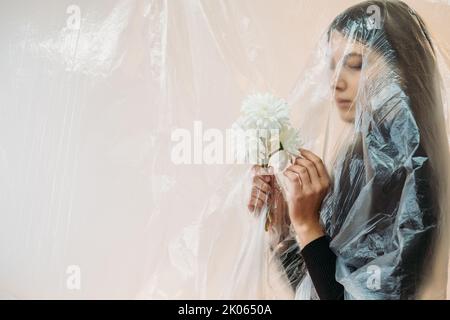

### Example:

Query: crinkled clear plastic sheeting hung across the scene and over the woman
xmin=0 ymin=0 xmax=450 ymax=299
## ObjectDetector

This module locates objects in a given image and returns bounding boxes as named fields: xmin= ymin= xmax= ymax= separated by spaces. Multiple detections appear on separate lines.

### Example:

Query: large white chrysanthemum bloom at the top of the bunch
xmin=241 ymin=93 xmax=290 ymax=130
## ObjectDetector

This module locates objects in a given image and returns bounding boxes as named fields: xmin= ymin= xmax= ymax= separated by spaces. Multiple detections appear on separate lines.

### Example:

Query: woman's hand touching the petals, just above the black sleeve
xmin=284 ymin=149 xmax=330 ymax=248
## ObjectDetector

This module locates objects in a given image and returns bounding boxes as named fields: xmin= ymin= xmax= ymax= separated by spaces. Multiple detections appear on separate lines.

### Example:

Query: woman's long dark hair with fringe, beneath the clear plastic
xmin=328 ymin=0 xmax=448 ymax=192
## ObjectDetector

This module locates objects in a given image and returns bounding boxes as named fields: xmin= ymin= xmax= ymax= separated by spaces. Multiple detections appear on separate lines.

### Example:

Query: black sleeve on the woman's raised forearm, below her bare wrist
xmin=301 ymin=236 xmax=344 ymax=300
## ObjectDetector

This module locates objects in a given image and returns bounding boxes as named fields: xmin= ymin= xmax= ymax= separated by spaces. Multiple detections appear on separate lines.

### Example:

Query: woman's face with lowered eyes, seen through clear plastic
xmin=330 ymin=31 xmax=365 ymax=123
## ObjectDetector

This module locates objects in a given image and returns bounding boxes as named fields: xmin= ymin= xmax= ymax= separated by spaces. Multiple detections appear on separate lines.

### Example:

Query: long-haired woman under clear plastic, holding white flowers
xmin=248 ymin=1 xmax=449 ymax=299
